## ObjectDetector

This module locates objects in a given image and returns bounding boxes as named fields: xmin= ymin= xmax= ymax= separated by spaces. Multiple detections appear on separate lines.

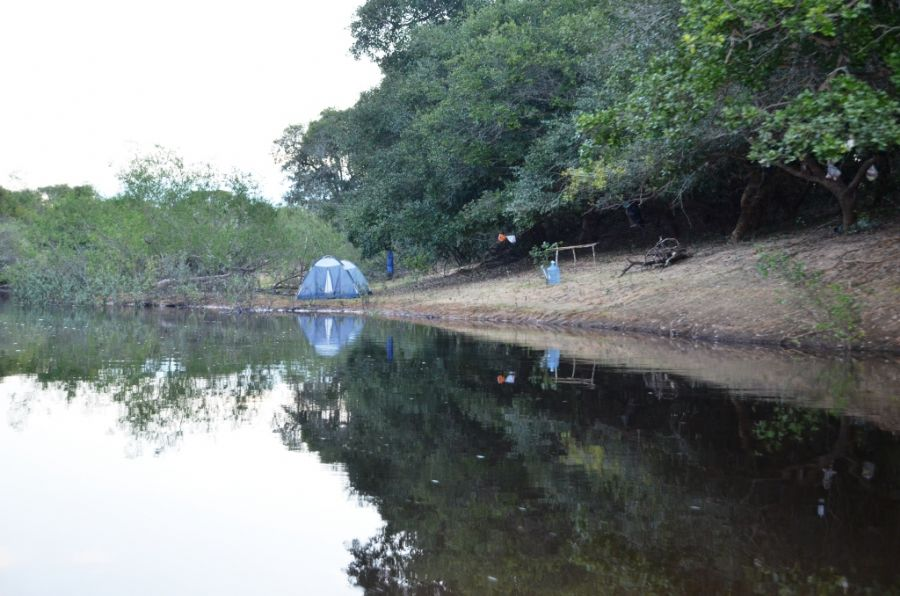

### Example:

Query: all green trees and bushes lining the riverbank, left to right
xmin=0 ymin=0 xmax=900 ymax=316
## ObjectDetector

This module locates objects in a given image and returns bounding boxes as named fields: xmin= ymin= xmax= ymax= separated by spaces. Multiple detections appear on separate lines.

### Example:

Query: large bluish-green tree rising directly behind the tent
xmin=278 ymin=0 xmax=673 ymax=261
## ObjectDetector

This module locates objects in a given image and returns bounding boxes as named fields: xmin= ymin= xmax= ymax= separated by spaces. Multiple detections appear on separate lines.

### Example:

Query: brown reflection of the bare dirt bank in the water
xmin=418 ymin=322 xmax=900 ymax=430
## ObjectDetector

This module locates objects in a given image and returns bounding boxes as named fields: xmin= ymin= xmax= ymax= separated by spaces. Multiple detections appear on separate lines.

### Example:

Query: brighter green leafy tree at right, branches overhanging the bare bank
xmin=572 ymin=0 xmax=900 ymax=229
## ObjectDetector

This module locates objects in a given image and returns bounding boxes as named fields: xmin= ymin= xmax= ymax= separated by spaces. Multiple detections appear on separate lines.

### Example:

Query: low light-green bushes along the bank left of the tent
xmin=0 ymin=153 xmax=357 ymax=303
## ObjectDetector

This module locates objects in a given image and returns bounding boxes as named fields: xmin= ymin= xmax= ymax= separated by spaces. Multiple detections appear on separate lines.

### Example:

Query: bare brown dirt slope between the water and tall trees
xmin=255 ymin=223 xmax=900 ymax=351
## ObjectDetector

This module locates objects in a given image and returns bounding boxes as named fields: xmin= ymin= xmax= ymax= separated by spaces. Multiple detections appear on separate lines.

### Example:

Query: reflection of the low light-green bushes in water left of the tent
xmin=0 ymin=305 xmax=322 ymax=452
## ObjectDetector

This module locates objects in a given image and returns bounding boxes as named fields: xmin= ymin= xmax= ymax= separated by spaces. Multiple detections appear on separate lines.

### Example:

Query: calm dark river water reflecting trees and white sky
xmin=0 ymin=303 xmax=900 ymax=595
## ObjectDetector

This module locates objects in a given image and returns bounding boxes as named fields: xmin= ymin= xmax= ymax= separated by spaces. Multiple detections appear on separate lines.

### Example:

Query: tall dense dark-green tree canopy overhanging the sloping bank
xmin=277 ymin=0 xmax=900 ymax=260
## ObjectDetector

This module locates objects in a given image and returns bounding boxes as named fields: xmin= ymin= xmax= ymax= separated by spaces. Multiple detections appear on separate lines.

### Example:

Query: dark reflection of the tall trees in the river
xmin=283 ymin=333 xmax=900 ymax=593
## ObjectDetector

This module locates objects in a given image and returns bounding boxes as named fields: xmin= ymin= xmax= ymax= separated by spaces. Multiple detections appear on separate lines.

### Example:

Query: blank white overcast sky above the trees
xmin=0 ymin=0 xmax=379 ymax=199
